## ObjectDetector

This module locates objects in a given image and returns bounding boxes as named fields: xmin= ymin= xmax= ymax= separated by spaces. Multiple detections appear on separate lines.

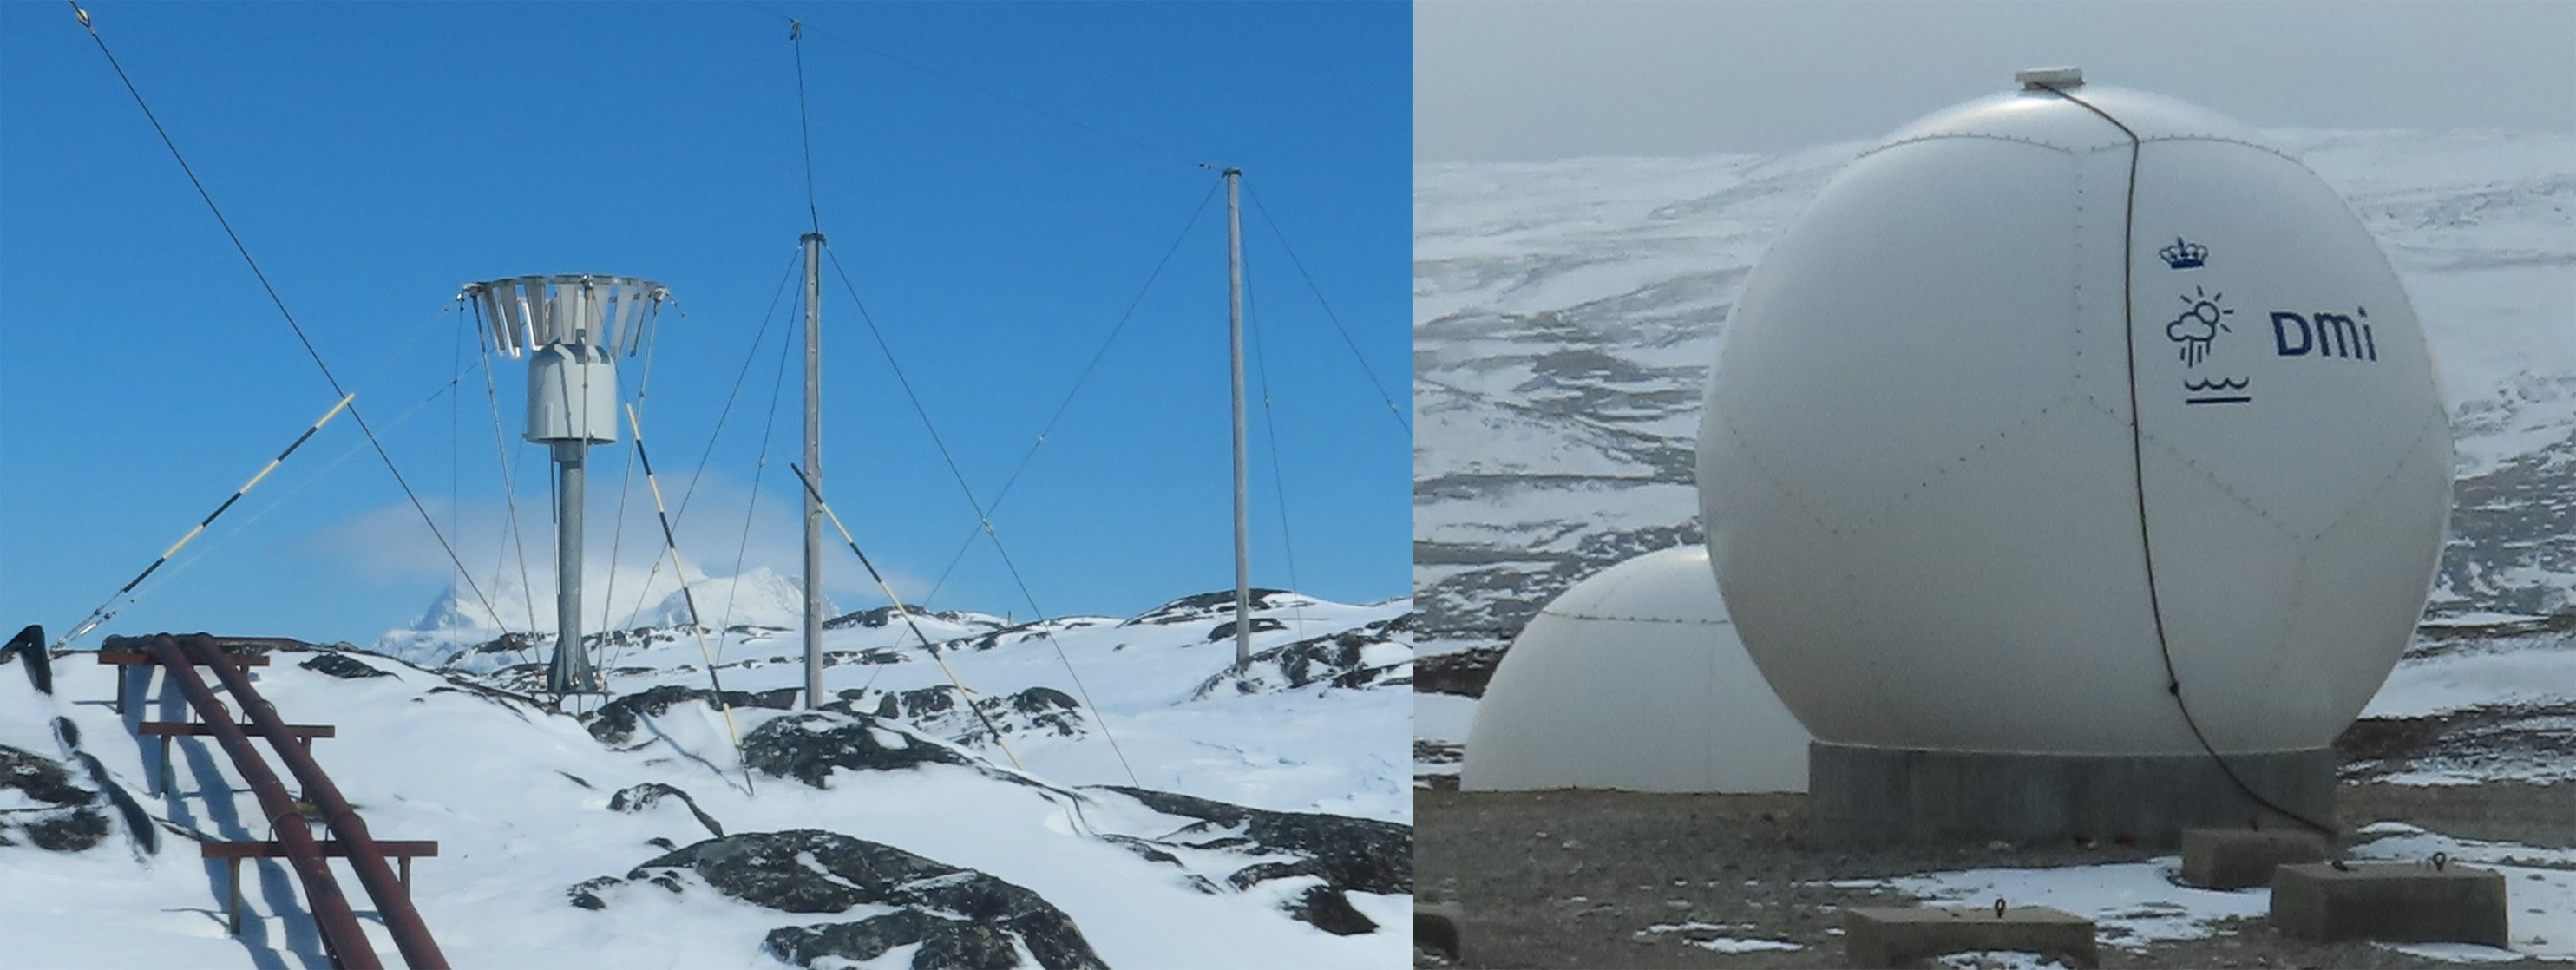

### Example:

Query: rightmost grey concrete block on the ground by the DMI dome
xmin=2272 ymin=862 xmax=2507 ymax=947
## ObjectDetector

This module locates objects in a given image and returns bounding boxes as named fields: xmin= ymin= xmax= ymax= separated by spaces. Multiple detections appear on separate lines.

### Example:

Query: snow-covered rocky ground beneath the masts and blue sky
xmin=0 ymin=573 xmax=1412 ymax=967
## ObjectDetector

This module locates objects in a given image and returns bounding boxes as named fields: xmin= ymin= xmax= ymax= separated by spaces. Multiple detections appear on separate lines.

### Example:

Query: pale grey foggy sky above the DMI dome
xmin=1414 ymin=0 xmax=2576 ymax=162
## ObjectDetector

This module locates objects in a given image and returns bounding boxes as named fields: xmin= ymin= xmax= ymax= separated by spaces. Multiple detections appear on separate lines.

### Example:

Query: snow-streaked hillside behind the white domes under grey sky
xmin=1414 ymin=131 xmax=2576 ymax=646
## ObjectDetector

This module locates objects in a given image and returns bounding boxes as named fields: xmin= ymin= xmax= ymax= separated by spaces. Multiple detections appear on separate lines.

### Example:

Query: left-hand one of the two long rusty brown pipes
xmin=120 ymin=633 xmax=383 ymax=970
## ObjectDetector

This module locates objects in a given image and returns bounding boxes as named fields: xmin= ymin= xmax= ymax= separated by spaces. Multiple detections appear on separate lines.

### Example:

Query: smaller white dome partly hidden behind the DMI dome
xmin=1458 ymin=546 xmax=1808 ymax=792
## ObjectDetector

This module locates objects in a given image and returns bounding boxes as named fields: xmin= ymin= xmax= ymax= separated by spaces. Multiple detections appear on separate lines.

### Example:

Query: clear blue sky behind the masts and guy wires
xmin=0 ymin=3 xmax=1412 ymax=643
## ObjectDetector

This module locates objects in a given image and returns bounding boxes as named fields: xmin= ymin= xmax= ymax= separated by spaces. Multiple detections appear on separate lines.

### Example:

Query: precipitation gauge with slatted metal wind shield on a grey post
xmin=458 ymin=272 xmax=670 ymax=695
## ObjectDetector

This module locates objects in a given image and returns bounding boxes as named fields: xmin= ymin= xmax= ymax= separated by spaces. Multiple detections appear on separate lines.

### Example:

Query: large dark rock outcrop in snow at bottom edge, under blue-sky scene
xmin=584 ymin=829 xmax=1108 ymax=970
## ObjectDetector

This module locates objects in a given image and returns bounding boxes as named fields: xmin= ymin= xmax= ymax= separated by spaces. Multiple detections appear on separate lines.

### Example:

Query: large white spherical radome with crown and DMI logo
xmin=1701 ymin=75 xmax=2452 ymax=754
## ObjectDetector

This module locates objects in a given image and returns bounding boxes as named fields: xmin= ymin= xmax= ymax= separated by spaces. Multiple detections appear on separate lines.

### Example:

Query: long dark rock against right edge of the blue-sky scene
xmin=1103 ymin=784 xmax=1414 ymax=895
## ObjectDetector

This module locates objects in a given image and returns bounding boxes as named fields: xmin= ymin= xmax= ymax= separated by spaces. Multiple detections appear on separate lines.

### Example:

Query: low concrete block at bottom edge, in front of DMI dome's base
xmin=1842 ymin=906 xmax=2102 ymax=967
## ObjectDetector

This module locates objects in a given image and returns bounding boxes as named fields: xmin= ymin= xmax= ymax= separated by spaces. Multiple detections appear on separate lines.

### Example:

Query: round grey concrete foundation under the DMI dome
xmin=1808 ymin=741 xmax=2334 ymax=849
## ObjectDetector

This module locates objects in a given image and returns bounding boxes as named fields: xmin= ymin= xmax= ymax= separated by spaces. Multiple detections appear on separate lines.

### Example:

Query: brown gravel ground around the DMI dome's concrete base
xmin=1414 ymin=783 xmax=2576 ymax=967
